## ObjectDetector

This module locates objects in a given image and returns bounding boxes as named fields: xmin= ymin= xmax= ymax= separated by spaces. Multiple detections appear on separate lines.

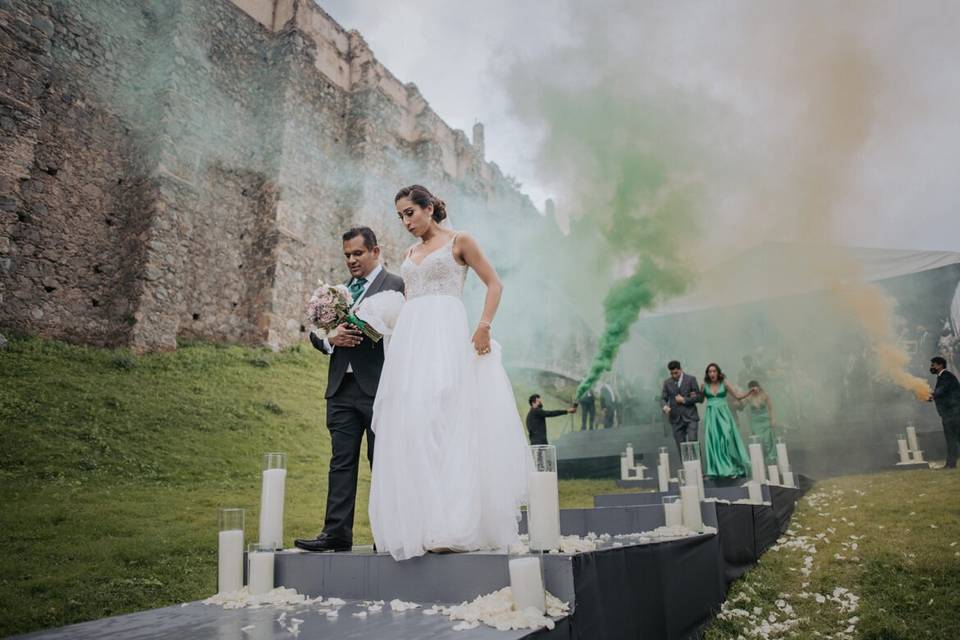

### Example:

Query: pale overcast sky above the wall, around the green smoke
xmin=320 ymin=0 xmax=960 ymax=250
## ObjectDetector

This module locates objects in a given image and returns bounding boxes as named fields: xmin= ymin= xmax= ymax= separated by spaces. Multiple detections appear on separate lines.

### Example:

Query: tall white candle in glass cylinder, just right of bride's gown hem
xmin=527 ymin=445 xmax=560 ymax=551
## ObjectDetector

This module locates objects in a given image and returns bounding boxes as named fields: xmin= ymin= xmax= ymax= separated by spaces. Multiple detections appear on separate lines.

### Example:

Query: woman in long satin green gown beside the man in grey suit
xmin=703 ymin=363 xmax=750 ymax=478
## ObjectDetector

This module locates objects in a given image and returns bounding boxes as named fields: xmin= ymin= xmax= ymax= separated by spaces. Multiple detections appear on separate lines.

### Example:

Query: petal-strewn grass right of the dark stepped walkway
xmin=706 ymin=471 xmax=960 ymax=640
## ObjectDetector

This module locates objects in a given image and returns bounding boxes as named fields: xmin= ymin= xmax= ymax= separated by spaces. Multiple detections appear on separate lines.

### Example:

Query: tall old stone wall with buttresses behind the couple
xmin=0 ymin=0 xmax=536 ymax=350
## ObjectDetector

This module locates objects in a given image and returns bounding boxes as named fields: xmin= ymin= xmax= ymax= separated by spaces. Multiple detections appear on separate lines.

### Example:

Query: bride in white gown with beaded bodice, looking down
xmin=370 ymin=185 xmax=530 ymax=560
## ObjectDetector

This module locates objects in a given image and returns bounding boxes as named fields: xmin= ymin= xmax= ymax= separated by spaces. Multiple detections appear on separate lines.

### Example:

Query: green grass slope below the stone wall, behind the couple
xmin=0 ymin=339 xmax=614 ymax=636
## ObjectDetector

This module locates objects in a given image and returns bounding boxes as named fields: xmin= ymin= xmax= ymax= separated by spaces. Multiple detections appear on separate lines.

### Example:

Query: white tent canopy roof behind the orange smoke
xmin=642 ymin=242 xmax=960 ymax=318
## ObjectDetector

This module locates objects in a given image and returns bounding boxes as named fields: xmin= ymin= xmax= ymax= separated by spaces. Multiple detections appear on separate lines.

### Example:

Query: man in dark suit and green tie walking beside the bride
xmin=294 ymin=227 xmax=403 ymax=551
